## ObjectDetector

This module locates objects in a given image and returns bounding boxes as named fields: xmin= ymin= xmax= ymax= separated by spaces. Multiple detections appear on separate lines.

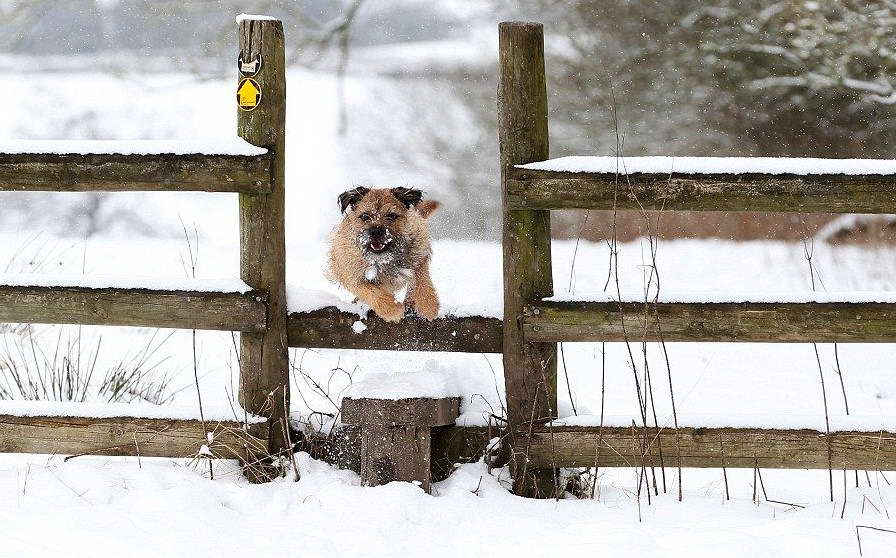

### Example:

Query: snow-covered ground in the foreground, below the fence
xmin=0 ymin=455 xmax=896 ymax=558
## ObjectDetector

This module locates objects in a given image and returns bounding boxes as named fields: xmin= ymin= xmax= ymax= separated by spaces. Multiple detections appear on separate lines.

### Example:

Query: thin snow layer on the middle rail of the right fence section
xmin=542 ymin=289 xmax=896 ymax=304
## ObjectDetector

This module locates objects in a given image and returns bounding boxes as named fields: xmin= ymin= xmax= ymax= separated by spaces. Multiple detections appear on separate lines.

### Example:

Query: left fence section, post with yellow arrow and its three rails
xmin=0 ymin=19 xmax=289 ymax=460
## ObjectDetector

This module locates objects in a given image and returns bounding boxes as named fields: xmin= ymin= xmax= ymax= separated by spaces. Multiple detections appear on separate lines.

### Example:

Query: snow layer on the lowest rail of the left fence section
xmin=0 ymin=401 xmax=267 ymax=424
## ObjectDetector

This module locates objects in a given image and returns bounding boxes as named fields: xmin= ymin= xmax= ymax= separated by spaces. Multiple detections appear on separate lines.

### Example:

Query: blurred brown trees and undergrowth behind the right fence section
xmin=476 ymin=0 xmax=896 ymax=240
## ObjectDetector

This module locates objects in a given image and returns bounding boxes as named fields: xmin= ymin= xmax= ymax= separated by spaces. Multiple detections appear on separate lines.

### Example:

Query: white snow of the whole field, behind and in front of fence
xmin=0 ymin=64 xmax=896 ymax=558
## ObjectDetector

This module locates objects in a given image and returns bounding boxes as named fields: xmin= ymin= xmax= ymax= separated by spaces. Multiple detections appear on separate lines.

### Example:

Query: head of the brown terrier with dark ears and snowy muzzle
xmin=339 ymin=187 xmax=438 ymax=257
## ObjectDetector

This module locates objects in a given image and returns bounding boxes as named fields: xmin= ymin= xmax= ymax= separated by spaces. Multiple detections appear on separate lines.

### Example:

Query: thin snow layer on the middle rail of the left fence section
xmin=0 ymin=273 xmax=252 ymax=294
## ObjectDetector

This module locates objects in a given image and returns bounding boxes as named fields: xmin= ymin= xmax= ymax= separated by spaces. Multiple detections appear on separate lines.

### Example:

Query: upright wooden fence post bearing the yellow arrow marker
xmin=237 ymin=19 xmax=289 ymax=454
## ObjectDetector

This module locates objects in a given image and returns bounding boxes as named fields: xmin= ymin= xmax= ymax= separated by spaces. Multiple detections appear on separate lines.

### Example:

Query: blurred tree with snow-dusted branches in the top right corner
xmin=683 ymin=0 xmax=896 ymax=157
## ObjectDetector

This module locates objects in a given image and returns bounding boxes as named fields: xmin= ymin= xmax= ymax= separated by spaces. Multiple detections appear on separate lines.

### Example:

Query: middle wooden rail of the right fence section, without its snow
xmin=523 ymin=302 xmax=896 ymax=343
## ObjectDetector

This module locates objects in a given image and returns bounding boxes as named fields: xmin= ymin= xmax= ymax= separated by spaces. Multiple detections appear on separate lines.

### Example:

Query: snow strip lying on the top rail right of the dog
xmin=517 ymin=156 xmax=896 ymax=175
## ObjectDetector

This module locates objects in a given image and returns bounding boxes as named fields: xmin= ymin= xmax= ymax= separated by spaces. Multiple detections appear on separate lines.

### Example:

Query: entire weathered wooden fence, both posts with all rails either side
xmin=0 ymin=19 xmax=896 ymax=496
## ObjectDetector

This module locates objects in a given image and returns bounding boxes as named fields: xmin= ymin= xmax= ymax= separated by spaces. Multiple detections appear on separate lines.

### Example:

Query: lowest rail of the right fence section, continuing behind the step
xmin=328 ymin=426 xmax=896 ymax=477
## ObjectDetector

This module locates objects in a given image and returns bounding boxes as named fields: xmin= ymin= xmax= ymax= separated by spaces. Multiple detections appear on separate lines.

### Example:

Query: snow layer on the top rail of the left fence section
xmin=0 ymin=136 xmax=268 ymax=157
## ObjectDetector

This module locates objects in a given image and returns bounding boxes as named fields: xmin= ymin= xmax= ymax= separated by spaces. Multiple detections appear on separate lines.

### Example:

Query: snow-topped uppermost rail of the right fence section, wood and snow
xmin=505 ymin=157 xmax=896 ymax=213
